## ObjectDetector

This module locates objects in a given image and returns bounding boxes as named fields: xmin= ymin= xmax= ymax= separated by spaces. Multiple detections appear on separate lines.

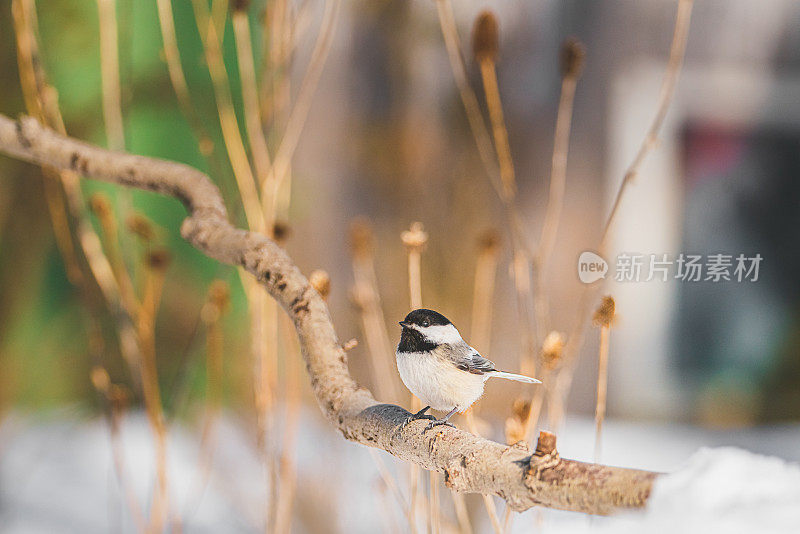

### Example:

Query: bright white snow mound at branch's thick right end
xmin=532 ymin=447 xmax=800 ymax=534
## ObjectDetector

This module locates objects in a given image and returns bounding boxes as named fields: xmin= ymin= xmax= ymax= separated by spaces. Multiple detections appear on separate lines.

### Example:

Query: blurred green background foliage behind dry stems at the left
xmin=0 ymin=1 xmax=253 ymax=409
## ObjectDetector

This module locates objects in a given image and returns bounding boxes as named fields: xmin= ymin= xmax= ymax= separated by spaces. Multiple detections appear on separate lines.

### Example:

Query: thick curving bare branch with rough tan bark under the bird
xmin=0 ymin=115 xmax=657 ymax=514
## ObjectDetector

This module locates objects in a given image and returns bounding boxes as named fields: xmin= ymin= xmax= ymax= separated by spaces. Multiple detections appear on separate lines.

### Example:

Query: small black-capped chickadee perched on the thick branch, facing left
xmin=397 ymin=309 xmax=541 ymax=430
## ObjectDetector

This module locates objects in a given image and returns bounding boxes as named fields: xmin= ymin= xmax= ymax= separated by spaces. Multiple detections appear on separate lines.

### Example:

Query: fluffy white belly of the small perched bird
xmin=397 ymin=352 xmax=486 ymax=412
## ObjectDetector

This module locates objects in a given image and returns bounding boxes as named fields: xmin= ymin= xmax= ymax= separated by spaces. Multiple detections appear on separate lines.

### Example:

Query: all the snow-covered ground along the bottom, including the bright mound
xmin=0 ymin=410 xmax=800 ymax=534
